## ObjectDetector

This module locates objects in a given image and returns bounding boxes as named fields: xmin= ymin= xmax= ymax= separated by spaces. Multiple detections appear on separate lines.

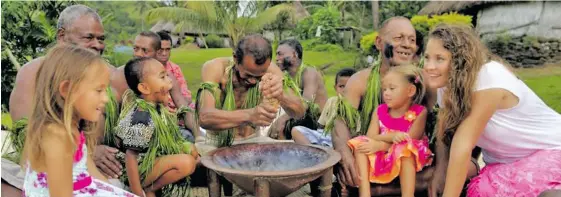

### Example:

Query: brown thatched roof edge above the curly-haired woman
xmin=419 ymin=0 xmax=515 ymax=15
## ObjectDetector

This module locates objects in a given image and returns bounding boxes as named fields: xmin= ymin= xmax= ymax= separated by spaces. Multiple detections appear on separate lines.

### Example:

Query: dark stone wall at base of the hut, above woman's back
xmin=486 ymin=37 xmax=561 ymax=68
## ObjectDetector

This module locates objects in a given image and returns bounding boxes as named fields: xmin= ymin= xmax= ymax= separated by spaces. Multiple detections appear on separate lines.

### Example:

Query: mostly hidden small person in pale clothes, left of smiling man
xmin=291 ymin=68 xmax=356 ymax=147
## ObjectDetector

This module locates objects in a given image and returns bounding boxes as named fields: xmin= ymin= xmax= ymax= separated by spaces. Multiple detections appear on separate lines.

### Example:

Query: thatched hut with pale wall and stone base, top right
xmin=419 ymin=0 xmax=561 ymax=67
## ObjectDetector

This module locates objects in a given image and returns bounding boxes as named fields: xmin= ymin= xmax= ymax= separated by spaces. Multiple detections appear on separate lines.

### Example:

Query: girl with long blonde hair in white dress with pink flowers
xmin=23 ymin=45 xmax=135 ymax=197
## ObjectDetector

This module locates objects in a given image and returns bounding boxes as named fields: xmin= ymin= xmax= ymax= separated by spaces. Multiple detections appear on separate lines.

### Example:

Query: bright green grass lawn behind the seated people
xmin=2 ymin=48 xmax=561 ymax=127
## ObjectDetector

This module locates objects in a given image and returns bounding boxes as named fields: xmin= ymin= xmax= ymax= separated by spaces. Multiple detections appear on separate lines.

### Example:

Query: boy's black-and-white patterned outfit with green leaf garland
xmin=114 ymin=89 xmax=193 ymax=197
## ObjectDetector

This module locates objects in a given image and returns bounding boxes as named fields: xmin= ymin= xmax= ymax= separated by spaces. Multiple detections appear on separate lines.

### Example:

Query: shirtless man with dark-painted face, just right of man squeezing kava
xmin=269 ymin=39 xmax=327 ymax=139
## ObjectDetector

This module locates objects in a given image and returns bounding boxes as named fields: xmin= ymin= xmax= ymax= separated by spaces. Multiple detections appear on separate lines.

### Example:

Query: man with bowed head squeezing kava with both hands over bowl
xmin=196 ymin=35 xmax=305 ymax=155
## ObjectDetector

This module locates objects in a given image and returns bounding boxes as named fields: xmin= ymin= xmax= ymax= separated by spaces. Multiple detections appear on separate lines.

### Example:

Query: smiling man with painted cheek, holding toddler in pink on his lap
xmin=325 ymin=17 xmax=478 ymax=196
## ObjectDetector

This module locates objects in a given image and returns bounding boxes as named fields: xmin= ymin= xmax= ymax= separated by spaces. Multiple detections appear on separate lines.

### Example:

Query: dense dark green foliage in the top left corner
xmin=1 ymin=1 xmax=74 ymax=107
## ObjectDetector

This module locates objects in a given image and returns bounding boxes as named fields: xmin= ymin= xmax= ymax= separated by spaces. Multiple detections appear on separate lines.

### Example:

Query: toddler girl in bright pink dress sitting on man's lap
xmin=348 ymin=66 xmax=432 ymax=196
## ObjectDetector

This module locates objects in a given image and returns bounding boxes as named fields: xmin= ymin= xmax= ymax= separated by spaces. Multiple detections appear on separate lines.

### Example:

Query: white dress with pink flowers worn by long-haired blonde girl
xmin=23 ymin=132 xmax=136 ymax=197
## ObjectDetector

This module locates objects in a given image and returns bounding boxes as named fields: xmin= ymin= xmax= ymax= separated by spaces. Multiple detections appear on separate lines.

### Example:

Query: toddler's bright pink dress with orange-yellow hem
xmin=347 ymin=104 xmax=433 ymax=184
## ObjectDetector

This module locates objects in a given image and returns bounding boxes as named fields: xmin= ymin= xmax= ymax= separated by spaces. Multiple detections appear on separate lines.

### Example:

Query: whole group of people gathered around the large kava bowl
xmin=2 ymin=5 xmax=561 ymax=196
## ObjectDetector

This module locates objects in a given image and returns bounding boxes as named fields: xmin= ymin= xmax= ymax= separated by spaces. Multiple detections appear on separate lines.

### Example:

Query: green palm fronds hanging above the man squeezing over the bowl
xmin=146 ymin=1 xmax=295 ymax=47
